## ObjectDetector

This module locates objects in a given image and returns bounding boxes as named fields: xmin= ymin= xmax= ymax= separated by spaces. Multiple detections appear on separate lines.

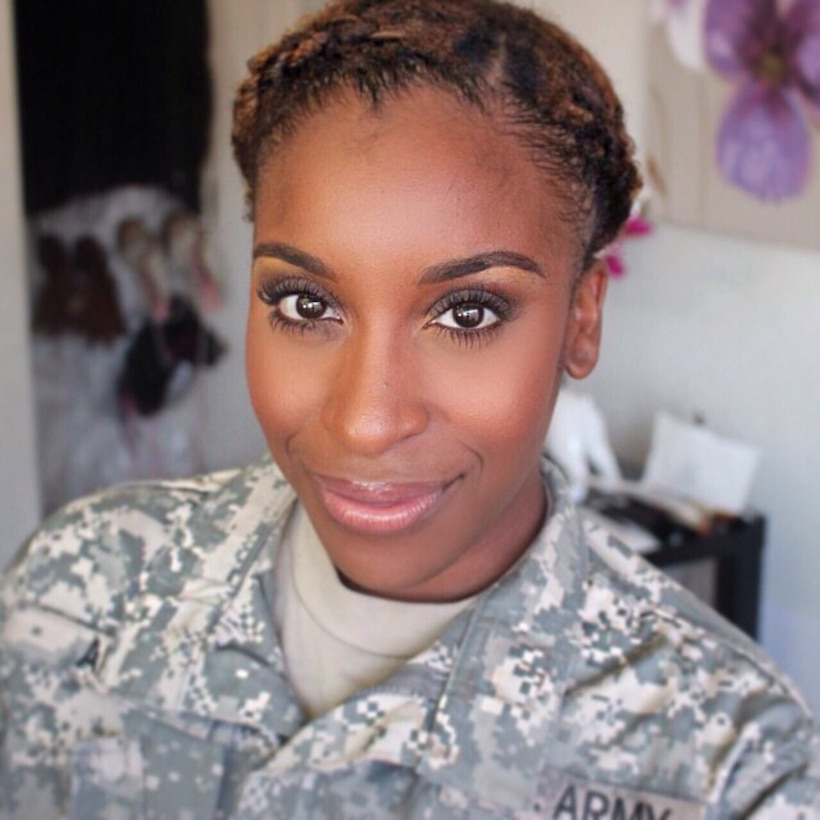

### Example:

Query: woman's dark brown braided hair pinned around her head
xmin=233 ymin=0 xmax=640 ymax=267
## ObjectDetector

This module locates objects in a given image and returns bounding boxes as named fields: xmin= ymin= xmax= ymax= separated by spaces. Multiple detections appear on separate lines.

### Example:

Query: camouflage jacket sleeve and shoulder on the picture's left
xmin=0 ymin=487 xmax=178 ymax=818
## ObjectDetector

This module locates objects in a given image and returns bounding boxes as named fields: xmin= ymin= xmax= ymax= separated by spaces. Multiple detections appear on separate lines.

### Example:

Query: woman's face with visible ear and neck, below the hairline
xmin=247 ymin=89 xmax=606 ymax=600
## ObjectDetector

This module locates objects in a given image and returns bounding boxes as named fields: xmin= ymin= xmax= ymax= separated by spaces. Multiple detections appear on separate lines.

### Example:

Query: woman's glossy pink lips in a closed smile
xmin=315 ymin=476 xmax=454 ymax=535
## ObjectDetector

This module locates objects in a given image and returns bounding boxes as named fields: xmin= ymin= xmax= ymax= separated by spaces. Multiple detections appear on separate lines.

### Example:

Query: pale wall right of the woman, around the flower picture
xmin=539 ymin=0 xmax=820 ymax=714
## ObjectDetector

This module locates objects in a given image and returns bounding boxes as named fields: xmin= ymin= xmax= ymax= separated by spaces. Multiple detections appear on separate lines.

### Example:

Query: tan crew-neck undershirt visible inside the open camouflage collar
xmin=274 ymin=507 xmax=474 ymax=717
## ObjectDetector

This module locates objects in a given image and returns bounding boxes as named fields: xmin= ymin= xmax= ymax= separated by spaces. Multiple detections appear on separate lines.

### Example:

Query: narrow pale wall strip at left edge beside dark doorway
xmin=0 ymin=0 xmax=39 ymax=566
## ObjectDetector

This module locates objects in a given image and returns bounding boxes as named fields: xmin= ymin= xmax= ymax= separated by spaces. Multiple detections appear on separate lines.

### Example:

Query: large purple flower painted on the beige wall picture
xmin=704 ymin=0 xmax=820 ymax=200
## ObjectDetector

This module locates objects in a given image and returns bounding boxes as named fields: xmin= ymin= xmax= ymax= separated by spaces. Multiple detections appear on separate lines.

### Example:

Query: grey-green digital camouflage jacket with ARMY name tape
xmin=0 ymin=460 xmax=819 ymax=820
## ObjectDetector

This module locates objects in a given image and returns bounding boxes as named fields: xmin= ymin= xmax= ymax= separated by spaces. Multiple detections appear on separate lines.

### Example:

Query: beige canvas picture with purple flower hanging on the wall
xmin=646 ymin=0 xmax=820 ymax=249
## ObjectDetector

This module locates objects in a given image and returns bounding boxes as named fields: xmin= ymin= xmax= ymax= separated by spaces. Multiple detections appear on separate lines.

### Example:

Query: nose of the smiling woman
xmin=322 ymin=326 xmax=429 ymax=456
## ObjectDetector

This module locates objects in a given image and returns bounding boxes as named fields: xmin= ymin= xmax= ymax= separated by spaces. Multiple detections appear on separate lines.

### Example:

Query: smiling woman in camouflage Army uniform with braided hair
xmin=0 ymin=0 xmax=818 ymax=819
